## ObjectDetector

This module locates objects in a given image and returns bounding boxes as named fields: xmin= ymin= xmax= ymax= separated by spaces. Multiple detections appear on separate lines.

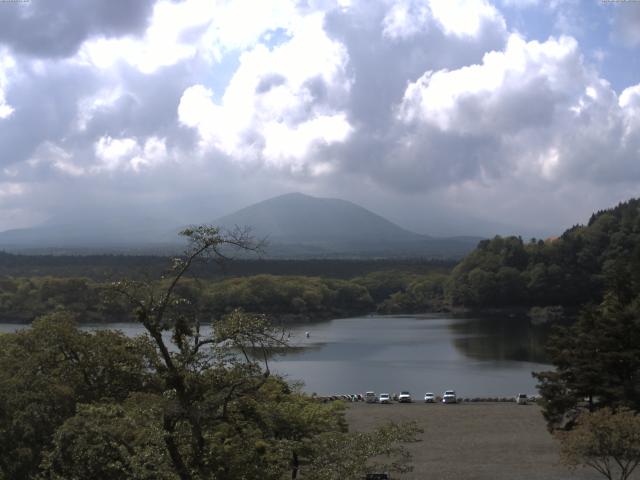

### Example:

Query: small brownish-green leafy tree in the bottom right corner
xmin=556 ymin=408 xmax=640 ymax=480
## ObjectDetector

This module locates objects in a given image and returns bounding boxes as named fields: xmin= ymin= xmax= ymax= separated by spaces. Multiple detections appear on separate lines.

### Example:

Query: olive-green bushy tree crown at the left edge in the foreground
xmin=0 ymin=313 xmax=156 ymax=480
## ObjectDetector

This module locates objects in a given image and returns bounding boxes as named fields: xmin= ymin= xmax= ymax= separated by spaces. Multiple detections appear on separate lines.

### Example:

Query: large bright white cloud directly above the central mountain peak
xmin=178 ymin=14 xmax=352 ymax=170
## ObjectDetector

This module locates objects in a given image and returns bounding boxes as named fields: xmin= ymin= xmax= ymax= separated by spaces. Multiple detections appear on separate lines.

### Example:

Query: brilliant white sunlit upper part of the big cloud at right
xmin=398 ymin=34 xmax=580 ymax=133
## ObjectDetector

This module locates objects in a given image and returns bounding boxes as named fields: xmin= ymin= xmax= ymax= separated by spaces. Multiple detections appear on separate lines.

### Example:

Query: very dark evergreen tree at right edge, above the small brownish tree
xmin=534 ymin=293 xmax=640 ymax=429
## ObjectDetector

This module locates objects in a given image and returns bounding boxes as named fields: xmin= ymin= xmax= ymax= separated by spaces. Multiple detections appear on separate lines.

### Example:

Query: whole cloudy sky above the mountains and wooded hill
xmin=0 ymin=0 xmax=640 ymax=235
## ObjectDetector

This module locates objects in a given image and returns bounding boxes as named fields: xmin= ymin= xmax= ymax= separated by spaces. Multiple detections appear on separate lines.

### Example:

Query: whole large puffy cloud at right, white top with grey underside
xmin=394 ymin=34 xmax=640 ymax=185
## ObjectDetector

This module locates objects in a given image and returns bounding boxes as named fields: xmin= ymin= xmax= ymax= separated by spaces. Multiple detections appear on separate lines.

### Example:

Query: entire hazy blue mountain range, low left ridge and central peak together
xmin=0 ymin=193 xmax=479 ymax=258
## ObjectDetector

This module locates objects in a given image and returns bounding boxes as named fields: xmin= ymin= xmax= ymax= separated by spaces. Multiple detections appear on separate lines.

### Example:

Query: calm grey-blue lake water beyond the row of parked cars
xmin=0 ymin=316 xmax=551 ymax=398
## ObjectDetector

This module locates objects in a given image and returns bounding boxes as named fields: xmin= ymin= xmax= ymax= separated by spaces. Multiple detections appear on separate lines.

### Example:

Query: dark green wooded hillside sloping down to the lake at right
xmin=446 ymin=199 xmax=640 ymax=307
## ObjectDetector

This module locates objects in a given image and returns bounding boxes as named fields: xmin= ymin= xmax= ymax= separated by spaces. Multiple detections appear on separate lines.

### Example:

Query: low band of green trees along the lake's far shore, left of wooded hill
xmin=0 ymin=270 xmax=456 ymax=323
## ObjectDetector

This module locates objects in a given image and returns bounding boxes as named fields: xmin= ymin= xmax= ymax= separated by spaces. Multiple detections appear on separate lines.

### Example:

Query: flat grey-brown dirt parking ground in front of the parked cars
xmin=347 ymin=403 xmax=602 ymax=480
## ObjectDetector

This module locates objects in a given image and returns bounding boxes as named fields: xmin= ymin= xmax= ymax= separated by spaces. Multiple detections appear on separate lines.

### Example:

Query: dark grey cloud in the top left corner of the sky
xmin=0 ymin=0 xmax=155 ymax=58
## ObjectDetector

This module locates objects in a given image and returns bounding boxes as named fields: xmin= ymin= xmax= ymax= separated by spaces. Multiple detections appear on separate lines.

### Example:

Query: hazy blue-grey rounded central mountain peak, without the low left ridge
xmin=214 ymin=193 xmax=480 ymax=258
